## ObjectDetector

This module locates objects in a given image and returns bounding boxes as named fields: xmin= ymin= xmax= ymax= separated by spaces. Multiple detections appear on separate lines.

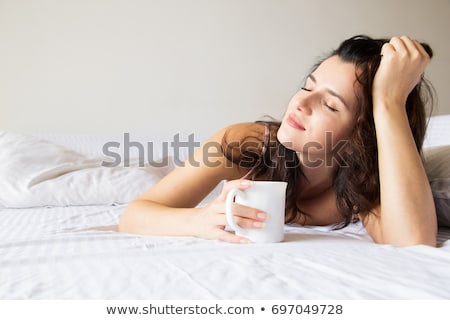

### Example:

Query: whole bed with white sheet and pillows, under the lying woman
xmin=0 ymin=115 xmax=450 ymax=300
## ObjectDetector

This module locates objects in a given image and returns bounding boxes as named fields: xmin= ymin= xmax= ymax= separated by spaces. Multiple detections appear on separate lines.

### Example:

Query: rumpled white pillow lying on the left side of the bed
xmin=0 ymin=132 xmax=173 ymax=208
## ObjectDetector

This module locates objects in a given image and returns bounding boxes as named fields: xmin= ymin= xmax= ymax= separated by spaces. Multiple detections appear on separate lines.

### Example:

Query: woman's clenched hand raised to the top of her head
xmin=372 ymin=36 xmax=430 ymax=108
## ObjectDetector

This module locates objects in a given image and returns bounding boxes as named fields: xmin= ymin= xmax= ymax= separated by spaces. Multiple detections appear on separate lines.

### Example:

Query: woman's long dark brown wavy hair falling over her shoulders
xmin=222 ymin=35 xmax=434 ymax=229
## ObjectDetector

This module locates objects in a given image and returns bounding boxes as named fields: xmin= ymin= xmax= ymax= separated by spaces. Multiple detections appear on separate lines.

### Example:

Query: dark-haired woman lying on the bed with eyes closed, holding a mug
xmin=119 ymin=36 xmax=437 ymax=246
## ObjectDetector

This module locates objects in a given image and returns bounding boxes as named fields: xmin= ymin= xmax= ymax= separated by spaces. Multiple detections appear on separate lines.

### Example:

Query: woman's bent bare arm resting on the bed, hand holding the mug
xmin=119 ymin=124 xmax=263 ymax=243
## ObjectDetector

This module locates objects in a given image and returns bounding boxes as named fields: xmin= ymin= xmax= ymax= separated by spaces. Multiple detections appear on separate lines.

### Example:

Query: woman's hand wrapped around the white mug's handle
xmin=194 ymin=179 xmax=267 ymax=243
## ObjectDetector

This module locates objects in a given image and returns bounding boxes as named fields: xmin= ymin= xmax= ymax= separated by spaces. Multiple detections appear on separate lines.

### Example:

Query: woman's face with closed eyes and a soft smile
xmin=277 ymin=56 xmax=360 ymax=163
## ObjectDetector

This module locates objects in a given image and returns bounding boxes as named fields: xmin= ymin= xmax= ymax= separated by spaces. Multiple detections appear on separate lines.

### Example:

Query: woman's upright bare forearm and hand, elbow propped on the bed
xmin=362 ymin=37 xmax=437 ymax=246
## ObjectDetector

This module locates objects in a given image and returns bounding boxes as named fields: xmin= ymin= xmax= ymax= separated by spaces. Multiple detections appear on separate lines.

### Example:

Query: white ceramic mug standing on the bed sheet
xmin=225 ymin=181 xmax=287 ymax=243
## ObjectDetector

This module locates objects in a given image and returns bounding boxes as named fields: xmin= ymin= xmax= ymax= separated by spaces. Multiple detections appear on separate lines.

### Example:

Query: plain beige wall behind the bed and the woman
xmin=0 ymin=0 xmax=450 ymax=136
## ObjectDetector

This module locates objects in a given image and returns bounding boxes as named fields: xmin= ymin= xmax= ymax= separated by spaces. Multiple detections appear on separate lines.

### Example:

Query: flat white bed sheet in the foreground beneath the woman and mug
xmin=0 ymin=206 xmax=450 ymax=299
